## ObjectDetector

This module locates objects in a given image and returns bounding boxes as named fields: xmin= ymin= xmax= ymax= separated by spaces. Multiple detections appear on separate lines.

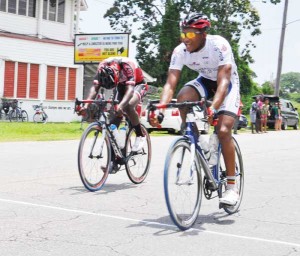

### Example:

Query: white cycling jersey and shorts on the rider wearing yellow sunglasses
xmin=169 ymin=35 xmax=240 ymax=114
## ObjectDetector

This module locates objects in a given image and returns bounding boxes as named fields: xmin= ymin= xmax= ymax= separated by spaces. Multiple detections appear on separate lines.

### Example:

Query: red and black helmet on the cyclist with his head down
xmin=98 ymin=62 xmax=120 ymax=89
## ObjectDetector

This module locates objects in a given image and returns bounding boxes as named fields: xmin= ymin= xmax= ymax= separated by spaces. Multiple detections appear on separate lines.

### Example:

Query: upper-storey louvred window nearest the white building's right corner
xmin=43 ymin=0 xmax=65 ymax=23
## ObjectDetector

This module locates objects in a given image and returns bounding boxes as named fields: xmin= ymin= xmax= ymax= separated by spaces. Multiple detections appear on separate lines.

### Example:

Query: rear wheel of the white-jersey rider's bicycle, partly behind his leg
xmin=218 ymin=138 xmax=244 ymax=214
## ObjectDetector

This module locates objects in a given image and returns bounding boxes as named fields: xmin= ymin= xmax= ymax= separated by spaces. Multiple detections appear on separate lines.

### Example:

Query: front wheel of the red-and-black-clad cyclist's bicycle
xmin=78 ymin=122 xmax=111 ymax=192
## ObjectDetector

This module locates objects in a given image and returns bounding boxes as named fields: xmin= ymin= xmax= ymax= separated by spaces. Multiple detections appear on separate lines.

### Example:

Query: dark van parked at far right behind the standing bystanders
xmin=253 ymin=95 xmax=299 ymax=130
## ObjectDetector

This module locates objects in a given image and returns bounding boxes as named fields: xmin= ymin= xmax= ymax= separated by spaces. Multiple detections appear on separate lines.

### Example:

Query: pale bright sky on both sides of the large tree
xmin=80 ymin=0 xmax=300 ymax=84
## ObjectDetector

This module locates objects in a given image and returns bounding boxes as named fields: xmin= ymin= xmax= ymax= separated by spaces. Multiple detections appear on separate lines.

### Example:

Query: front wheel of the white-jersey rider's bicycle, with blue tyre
xmin=164 ymin=137 xmax=203 ymax=230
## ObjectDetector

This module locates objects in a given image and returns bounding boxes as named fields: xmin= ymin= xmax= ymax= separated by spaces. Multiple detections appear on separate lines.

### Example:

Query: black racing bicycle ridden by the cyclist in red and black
xmin=75 ymin=98 xmax=151 ymax=191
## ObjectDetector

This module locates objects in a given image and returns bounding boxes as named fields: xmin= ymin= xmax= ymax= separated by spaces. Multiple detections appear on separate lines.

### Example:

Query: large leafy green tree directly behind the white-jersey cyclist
xmin=104 ymin=0 xmax=281 ymax=94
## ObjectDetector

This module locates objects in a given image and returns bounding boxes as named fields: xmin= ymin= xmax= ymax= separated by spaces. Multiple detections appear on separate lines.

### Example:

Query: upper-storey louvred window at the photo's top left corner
xmin=0 ymin=0 xmax=36 ymax=17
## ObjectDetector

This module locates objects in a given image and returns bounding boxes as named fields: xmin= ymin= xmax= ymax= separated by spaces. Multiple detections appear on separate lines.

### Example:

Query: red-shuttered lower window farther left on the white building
xmin=3 ymin=61 xmax=40 ymax=99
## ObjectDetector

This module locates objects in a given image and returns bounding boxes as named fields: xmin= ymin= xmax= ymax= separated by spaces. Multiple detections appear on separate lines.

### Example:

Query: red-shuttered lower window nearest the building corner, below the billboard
xmin=46 ymin=66 xmax=76 ymax=100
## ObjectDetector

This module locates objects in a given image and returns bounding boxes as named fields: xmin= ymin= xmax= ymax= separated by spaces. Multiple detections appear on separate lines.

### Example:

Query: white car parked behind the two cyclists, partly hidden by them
xmin=141 ymin=99 xmax=210 ymax=134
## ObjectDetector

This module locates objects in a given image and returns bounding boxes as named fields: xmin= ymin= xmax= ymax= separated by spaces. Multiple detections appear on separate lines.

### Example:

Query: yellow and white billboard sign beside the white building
xmin=74 ymin=33 xmax=129 ymax=64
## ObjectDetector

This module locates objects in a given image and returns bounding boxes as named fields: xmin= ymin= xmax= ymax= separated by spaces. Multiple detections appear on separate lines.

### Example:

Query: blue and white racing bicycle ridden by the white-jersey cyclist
xmin=148 ymin=100 xmax=244 ymax=230
